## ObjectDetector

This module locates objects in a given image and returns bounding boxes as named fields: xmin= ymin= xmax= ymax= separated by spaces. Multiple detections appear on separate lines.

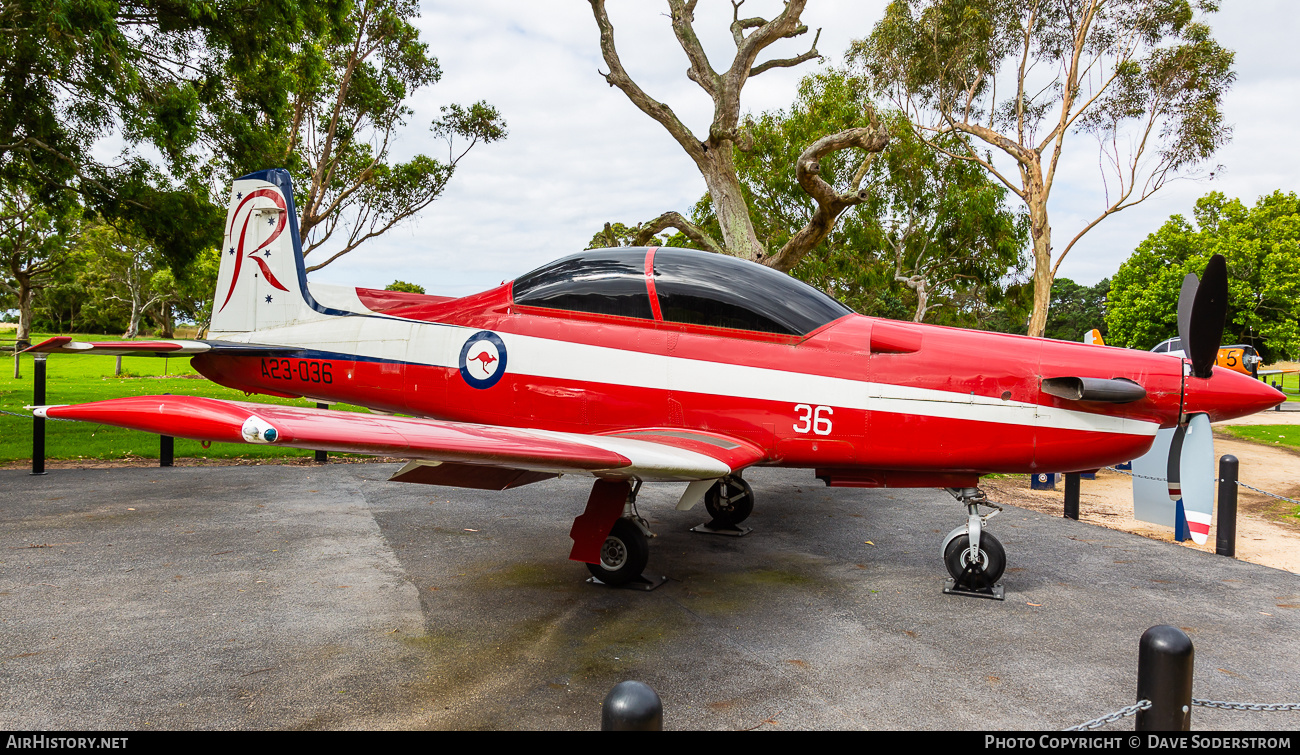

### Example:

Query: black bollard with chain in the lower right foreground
xmin=1134 ymin=624 xmax=1196 ymax=732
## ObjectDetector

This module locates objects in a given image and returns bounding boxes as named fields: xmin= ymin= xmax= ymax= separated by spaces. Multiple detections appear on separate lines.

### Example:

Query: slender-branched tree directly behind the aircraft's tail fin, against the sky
xmin=273 ymin=0 xmax=506 ymax=272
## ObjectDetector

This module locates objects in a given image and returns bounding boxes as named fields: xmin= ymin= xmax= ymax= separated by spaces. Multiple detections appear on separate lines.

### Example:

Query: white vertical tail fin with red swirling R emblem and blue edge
xmin=211 ymin=169 xmax=346 ymax=338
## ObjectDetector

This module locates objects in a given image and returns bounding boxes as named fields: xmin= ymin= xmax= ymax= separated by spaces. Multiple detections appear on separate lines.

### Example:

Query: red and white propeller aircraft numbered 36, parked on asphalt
xmin=31 ymin=170 xmax=1283 ymax=585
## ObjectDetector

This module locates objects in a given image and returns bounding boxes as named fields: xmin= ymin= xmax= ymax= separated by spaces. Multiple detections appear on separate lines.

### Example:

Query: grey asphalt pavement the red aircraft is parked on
xmin=0 ymin=464 xmax=1300 ymax=730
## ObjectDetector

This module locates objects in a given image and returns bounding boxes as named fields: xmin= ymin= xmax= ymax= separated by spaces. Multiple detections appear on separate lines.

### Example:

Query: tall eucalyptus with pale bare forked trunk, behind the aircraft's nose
xmin=850 ymin=0 xmax=1234 ymax=335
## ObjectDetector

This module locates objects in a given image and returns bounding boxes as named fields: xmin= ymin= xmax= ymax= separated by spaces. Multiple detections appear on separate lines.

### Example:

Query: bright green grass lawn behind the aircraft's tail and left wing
xmin=0 ymin=335 xmax=364 ymax=464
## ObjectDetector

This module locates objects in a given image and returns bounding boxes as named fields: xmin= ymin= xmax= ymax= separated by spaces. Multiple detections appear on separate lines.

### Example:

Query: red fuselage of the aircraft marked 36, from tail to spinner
xmin=194 ymin=275 xmax=1277 ymax=486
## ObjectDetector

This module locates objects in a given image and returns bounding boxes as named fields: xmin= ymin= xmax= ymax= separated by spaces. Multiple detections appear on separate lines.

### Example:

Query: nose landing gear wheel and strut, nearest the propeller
xmin=940 ymin=487 xmax=1006 ymax=600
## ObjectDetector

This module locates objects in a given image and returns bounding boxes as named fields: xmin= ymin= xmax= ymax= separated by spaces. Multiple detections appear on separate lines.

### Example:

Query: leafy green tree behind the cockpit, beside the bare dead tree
xmin=698 ymin=69 xmax=1028 ymax=325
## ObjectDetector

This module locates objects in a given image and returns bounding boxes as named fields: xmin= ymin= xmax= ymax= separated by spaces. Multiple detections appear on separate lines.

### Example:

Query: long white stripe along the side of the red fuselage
xmin=213 ymin=310 xmax=1158 ymax=437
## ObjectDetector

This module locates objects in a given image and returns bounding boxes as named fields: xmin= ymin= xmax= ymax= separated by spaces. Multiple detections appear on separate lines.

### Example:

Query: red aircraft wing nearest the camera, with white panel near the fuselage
xmin=33 ymin=396 xmax=763 ymax=483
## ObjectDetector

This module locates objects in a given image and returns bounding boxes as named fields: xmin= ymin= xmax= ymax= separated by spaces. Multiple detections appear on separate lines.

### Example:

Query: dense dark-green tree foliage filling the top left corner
xmin=0 ymin=0 xmax=347 ymax=265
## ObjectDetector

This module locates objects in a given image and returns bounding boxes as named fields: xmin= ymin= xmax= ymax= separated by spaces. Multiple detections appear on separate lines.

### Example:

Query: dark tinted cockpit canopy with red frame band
xmin=512 ymin=247 xmax=853 ymax=335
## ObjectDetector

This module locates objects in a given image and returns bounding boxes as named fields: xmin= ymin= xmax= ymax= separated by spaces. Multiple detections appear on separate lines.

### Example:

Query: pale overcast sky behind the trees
xmin=301 ymin=0 xmax=1300 ymax=295
